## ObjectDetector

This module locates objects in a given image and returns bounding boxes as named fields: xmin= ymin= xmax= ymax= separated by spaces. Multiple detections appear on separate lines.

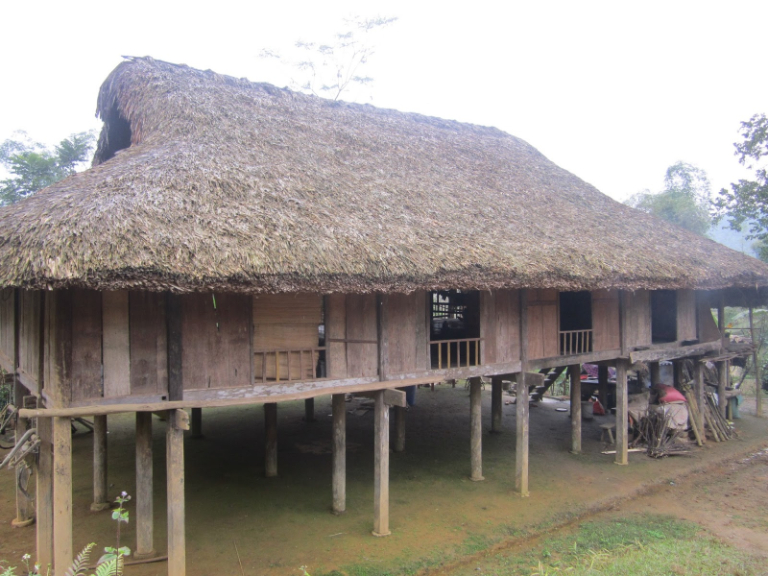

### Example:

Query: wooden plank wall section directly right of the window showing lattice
xmin=480 ymin=290 xmax=520 ymax=364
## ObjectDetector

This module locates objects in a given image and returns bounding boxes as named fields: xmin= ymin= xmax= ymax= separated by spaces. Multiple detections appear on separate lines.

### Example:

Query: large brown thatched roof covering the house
xmin=0 ymin=58 xmax=768 ymax=292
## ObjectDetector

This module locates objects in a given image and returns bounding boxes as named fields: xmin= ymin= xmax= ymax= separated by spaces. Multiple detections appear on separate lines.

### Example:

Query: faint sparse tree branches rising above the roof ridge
xmin=261 ymin=16 xmax=397 ymax=100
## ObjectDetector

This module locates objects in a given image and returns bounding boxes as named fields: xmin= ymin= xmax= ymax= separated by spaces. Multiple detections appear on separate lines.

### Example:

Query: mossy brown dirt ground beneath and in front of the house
xmin=0 ymin=386 xmax=768 ymax=576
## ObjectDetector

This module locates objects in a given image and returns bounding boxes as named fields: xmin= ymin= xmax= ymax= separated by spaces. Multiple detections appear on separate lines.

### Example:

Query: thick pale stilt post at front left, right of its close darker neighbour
xmin=53 ymin=418 xmax=73 ymax=574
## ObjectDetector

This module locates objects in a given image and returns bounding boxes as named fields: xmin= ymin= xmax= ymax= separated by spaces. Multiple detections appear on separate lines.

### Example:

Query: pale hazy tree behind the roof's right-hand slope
xmin=626 ymin=162 xmax=712 ymax=236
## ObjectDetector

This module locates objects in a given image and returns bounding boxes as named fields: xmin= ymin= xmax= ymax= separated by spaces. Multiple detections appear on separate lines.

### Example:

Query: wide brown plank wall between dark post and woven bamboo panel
xmin=181 ymin=293 xmax=253 ymax=390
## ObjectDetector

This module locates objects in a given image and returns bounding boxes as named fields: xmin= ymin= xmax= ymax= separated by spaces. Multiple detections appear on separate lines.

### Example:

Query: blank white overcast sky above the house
xmin=0 ymin=0 xmax=768 ymax=200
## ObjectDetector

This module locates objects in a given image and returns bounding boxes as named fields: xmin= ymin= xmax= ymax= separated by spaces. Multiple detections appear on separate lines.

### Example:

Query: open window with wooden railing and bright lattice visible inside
xmin=429 ymin=290 xmax=480 ymax=370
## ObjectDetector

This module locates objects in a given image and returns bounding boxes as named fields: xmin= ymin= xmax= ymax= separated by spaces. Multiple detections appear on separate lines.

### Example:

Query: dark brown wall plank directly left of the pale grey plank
xmin=71 ymin=290 xmax=103 ymax=401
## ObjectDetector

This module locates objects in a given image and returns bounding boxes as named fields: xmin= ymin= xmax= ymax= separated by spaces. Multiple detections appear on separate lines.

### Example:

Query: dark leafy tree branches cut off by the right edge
xmin=714 ymin=114 xmax=768 ymax=245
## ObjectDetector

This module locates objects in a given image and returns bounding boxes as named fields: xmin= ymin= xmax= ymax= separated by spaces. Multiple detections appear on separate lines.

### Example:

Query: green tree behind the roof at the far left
xmin=0 ymin=132 xmax=96 ymax=206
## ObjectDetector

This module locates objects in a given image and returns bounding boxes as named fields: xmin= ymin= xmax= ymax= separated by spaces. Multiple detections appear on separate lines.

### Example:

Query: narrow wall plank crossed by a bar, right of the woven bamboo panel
xmin=346 ymin=294 xmax=379 ymax=378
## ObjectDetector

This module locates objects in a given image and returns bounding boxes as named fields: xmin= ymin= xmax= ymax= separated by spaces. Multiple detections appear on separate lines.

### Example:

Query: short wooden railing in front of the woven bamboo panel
xmin=253 ymin=346 xmax=326 ymax=383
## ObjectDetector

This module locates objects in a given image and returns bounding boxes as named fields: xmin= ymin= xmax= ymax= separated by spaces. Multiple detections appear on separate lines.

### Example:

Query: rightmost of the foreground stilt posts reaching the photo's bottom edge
xmin=165 ymin=410 xmax=189 ymax=576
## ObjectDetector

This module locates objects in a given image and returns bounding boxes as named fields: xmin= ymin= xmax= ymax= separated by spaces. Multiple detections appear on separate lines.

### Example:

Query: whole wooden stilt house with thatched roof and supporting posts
xmin=0 ymin=58 xmax=768 ymax=576
